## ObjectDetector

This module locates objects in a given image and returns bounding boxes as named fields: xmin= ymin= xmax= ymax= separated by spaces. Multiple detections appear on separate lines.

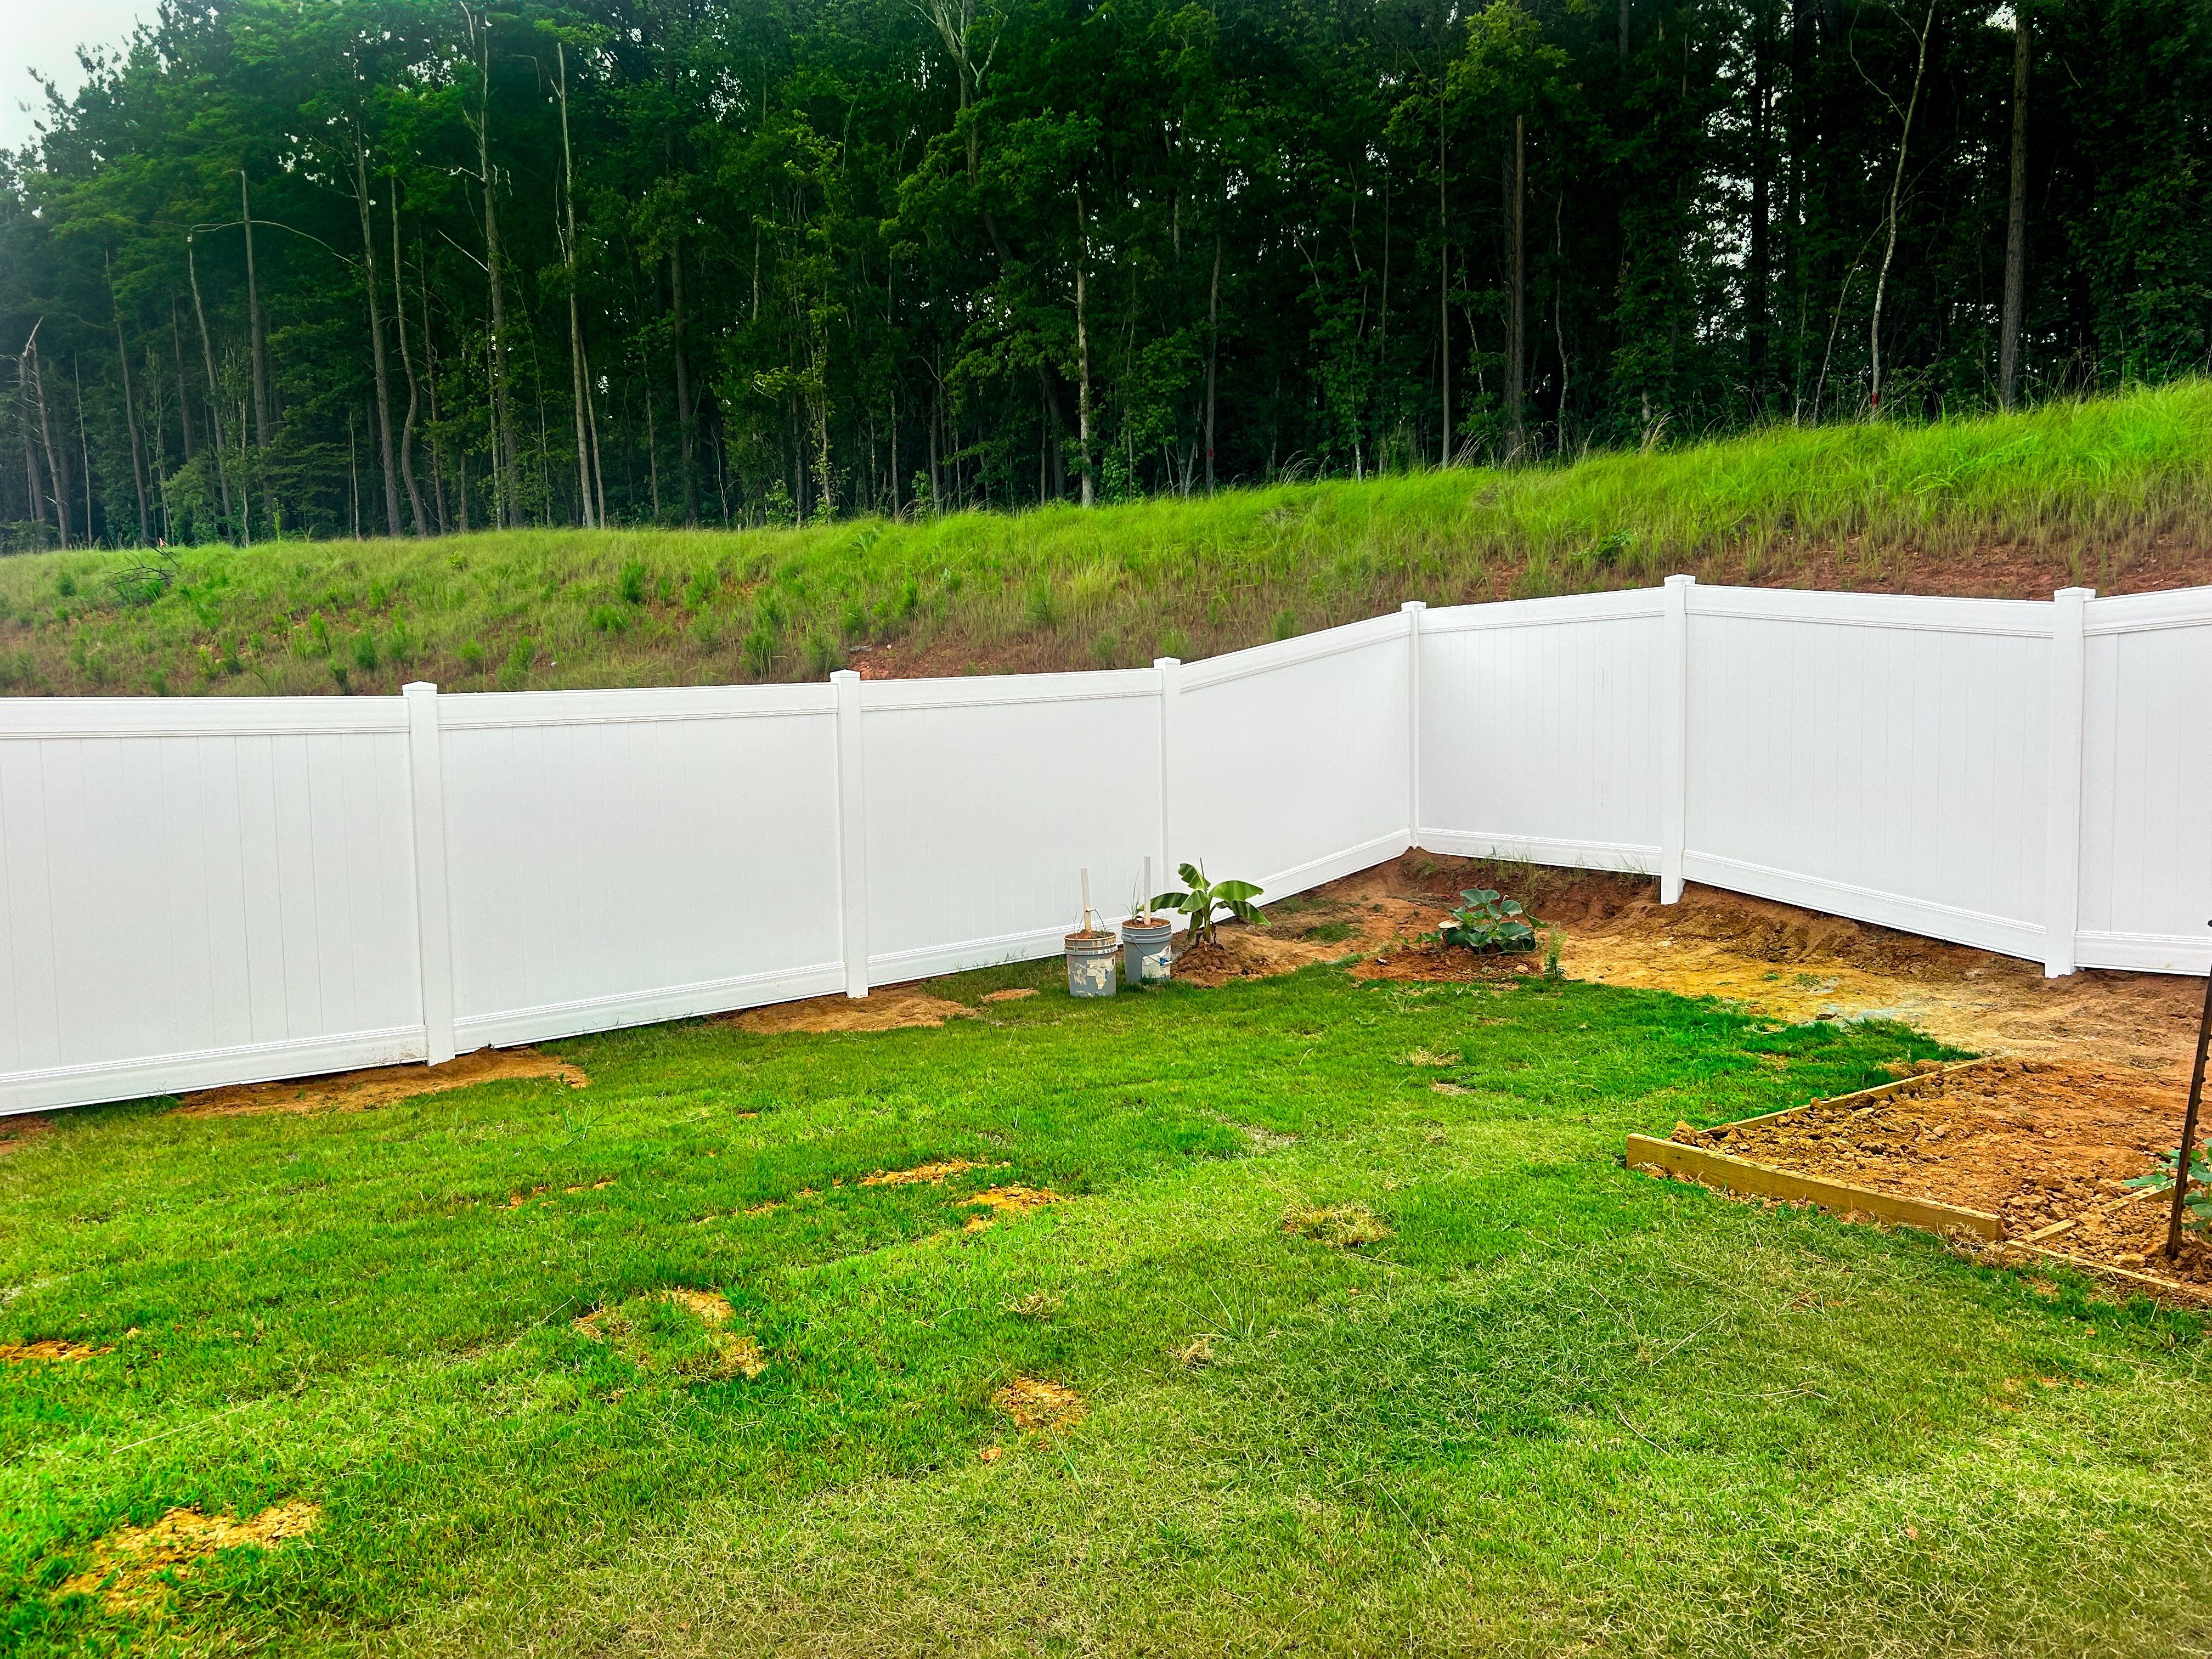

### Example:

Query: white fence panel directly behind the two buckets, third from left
xmin=860 ymin=668 xmax=1159 ymax=984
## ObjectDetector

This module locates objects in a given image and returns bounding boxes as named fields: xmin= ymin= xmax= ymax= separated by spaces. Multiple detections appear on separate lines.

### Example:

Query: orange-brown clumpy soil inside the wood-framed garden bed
xmin=1677 ymin=1059 xmax=2212 ymax=1283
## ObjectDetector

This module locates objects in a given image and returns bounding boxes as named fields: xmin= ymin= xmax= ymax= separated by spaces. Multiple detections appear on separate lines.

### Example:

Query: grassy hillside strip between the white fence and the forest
xmin=0 ymin=381 xmax=2212 ymax=695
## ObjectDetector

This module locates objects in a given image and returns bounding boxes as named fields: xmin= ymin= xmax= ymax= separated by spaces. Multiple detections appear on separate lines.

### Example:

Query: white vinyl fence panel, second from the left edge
xmin=438 ymin=686 xmax=843 ymax=1053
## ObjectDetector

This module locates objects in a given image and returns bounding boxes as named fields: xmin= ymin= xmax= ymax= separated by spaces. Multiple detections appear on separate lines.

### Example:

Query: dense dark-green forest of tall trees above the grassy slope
xmin=0 ymin=0 xmax=2212 ymax=549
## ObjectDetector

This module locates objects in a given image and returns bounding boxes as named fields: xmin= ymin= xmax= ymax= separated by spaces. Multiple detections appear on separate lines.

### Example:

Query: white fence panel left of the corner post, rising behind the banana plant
xmin=1164 ymin=613 xmax=1411 ymax=898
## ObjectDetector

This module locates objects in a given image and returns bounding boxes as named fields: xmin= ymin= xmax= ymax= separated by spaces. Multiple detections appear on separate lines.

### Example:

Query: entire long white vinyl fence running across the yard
xmin=0 ymin=577 xmax=2212 ymax=1113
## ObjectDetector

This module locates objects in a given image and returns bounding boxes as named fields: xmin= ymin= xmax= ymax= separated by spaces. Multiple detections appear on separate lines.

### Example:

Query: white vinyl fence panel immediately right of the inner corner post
xmin=1415 ymin=589 xmax=1661 ymax=872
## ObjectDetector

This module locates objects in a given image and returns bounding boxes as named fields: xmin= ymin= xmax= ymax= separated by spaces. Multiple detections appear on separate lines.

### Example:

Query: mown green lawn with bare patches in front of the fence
xmin=0 ymin=964 xmax=2212 ymax=1657
